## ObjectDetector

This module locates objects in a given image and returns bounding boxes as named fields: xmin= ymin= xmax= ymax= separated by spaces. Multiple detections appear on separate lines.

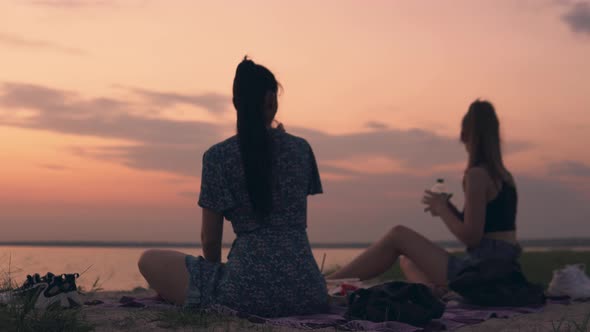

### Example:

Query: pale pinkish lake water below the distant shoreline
xmin=0 ymin=246 xmax=590 ymax=290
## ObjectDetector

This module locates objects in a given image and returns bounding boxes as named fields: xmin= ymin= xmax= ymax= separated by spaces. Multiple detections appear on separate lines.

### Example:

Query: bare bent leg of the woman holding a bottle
xmin=328 ymin=226 xmax=449 ymax=286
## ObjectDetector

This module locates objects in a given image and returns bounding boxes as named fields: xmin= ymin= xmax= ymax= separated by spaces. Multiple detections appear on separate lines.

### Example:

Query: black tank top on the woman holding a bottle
xmin=484 ymin=181 xmax=518 ymax=233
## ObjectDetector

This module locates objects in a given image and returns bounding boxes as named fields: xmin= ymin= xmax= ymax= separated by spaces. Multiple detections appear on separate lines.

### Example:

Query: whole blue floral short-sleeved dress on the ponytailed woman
xmin=199 ymin=130 xmax=327 ymax=317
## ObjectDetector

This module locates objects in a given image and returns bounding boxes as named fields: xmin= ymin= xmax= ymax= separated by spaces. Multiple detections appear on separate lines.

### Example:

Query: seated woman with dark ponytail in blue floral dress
xmin=139 ymin=58 xmax=328 ymax=317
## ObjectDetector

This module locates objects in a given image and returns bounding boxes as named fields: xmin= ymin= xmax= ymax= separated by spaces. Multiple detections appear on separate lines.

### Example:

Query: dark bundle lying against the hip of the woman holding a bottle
xmin=449 ymin=259 xmax=545 ymax=307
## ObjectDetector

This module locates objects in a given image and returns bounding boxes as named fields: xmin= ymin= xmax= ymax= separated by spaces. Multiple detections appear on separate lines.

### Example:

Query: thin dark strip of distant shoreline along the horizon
xmin=0 ymin=238 xmax=590 ymax=249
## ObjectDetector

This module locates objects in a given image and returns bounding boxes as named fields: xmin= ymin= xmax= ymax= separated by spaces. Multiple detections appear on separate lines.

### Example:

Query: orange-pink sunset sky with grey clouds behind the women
xmin=0 ymin=0 xmax=590 ymax=242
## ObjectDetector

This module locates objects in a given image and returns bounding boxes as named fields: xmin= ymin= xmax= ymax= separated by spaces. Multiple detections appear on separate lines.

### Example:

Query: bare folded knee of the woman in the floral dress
xmin=137 ymin=249 xmax=189 ymax=305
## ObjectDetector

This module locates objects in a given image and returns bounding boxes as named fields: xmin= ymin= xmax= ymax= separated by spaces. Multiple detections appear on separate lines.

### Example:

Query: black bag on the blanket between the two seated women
xmin=346 ymin=281 xmax=445 ymax=326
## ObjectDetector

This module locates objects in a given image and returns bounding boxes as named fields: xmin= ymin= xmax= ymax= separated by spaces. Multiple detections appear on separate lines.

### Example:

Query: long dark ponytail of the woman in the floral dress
xmin=233 ymin=57 xmax=279 ymax=221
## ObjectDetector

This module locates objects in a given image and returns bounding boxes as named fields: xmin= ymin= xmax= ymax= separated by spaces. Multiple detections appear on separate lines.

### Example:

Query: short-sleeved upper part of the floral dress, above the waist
xmin=199 ymin=129 xmax=322 ymax=236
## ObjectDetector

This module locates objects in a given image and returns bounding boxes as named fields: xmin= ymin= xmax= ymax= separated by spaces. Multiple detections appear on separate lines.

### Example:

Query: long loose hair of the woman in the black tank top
xmin=461 ymin=99 xmax=514 ymax=184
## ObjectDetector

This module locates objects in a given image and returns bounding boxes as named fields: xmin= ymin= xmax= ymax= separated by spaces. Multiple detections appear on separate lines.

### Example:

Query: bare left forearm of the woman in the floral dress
xmin=201 ymin=208 xmax=223 ymax=263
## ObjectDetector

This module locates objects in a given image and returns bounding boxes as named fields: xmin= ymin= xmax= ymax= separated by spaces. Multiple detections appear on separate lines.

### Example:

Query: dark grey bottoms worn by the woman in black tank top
xmin=447 ymin=237 xmax=522 ymax=281
